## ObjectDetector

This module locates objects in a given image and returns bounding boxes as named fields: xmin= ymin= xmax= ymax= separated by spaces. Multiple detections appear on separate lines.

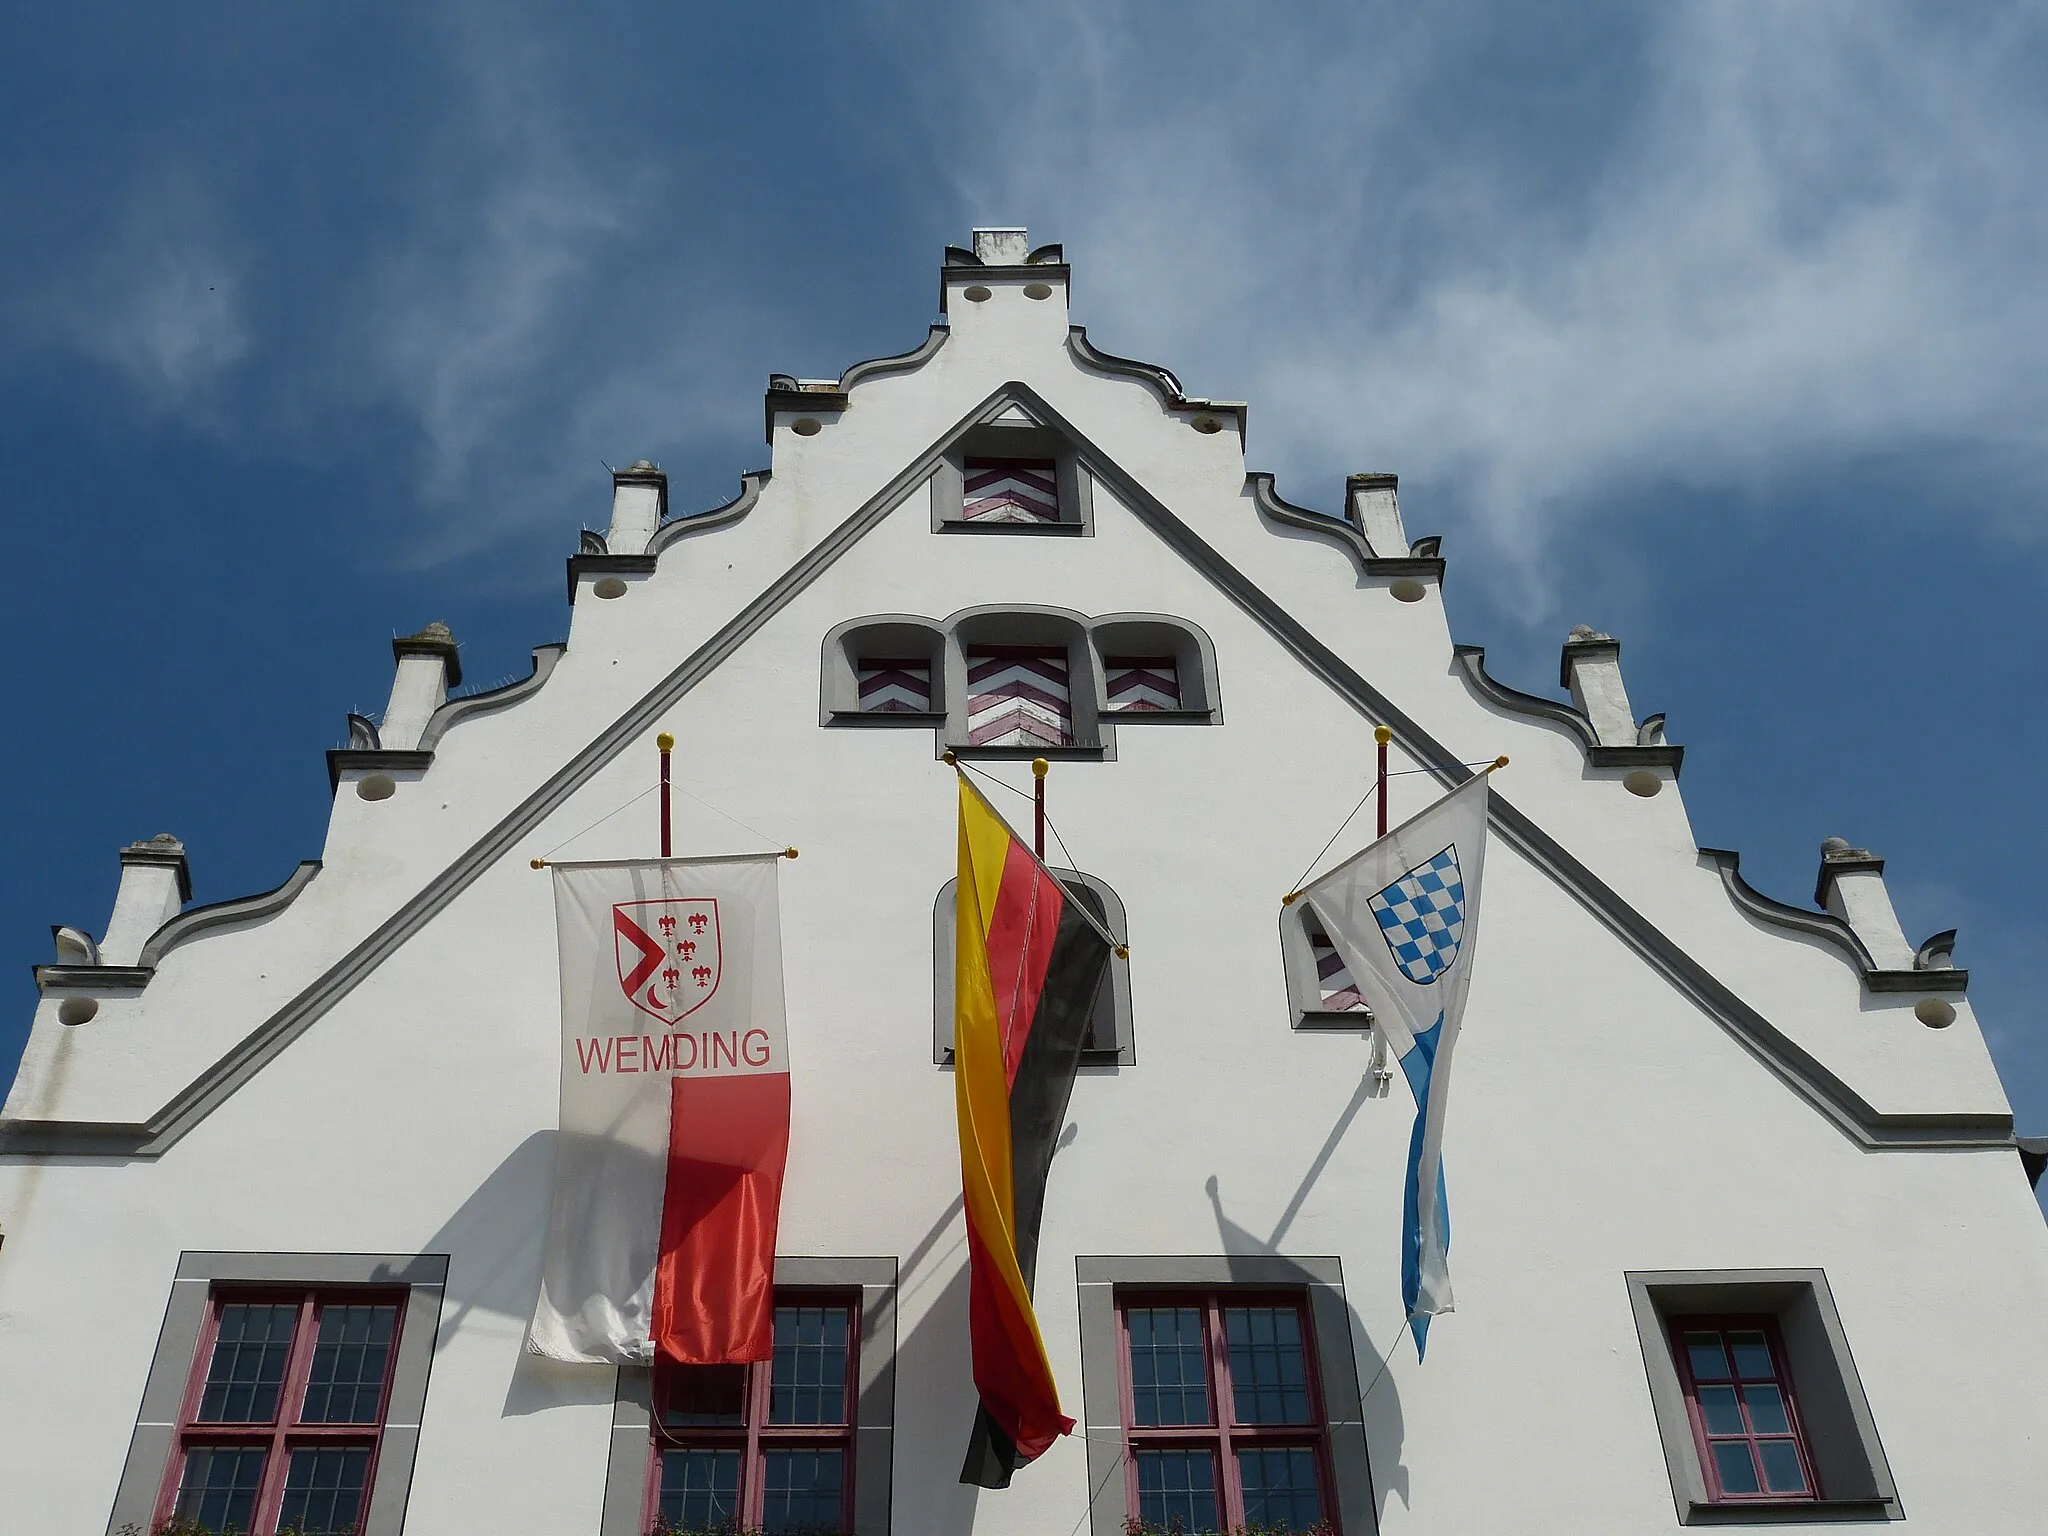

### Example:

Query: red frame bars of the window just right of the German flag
xmin=1116 ymin=1288 xmax=1337 ymax=1536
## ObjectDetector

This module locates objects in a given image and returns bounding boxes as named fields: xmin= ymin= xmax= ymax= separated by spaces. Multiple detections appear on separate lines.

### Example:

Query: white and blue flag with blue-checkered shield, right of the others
xmin=1303 ymin=774 xmax=1487 ymax=1360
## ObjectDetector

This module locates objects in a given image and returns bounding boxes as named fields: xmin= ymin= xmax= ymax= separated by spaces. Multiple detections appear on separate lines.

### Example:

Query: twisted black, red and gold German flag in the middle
xmin=952 ymin=774 xmax=1112 ymax=1489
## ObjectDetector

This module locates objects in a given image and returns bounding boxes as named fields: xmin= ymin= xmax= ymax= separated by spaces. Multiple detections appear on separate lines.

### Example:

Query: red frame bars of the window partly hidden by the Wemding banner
xmin=641 ymin=1288 xmax=860 ymax=1532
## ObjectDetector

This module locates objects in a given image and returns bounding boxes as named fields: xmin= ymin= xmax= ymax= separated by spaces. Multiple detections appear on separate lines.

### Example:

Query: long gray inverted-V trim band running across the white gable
xmin=0 ymin=381 xmax=2013 ymax=1157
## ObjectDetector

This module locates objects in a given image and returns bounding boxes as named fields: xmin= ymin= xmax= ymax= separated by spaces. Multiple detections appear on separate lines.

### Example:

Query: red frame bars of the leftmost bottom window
xmin=150 ymin=1286 xmax=406 ymax=1536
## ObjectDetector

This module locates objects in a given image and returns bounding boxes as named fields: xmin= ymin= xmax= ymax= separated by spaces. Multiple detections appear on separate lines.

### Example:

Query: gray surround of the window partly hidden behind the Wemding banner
xmin=598 ymin=1253 xmax=897 ymax=1536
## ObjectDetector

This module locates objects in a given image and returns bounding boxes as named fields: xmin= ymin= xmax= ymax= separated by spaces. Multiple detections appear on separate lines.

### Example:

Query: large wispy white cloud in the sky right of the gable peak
xmin=921 ymin=4 xmax=2048 ymax=616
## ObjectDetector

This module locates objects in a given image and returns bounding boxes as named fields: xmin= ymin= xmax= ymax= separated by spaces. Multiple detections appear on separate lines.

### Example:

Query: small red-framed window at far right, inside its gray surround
xmin=1671 ymin=1317 xmax=1819 ymax=1503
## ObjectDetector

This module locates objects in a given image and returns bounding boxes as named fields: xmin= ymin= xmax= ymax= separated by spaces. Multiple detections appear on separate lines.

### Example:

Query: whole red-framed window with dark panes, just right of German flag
xmin=1116 ymin=1290 xmax=1333 ymax=1534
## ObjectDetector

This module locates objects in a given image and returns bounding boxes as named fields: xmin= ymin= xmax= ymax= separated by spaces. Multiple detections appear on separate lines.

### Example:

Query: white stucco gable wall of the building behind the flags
xmin=0 ymin=240 xmax=2048 ymax=1536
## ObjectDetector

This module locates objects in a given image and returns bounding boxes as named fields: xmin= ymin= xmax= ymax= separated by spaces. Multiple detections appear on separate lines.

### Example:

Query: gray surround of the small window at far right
xmin=1626 ymin=1270 xmax=1905 ymax=1526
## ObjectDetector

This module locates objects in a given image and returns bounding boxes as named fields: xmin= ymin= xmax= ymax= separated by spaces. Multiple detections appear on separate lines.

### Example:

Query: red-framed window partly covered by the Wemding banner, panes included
xmin=647 ymin=1292 xmax=860 ymax=1536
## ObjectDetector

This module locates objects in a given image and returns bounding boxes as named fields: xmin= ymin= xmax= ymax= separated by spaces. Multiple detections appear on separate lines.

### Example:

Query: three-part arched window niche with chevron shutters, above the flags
xmin=819 ymin=604 xmax=1223 ymax=762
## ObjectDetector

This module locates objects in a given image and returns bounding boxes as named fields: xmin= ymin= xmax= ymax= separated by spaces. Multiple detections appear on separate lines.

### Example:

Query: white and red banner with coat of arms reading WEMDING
xmin=526 ymin=854 xmax=788 ymax=1364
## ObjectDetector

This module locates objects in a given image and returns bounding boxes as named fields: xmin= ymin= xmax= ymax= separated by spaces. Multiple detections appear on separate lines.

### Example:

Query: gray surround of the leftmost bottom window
xmin=106 ymin=1253 xmax=449 ymax=1536
